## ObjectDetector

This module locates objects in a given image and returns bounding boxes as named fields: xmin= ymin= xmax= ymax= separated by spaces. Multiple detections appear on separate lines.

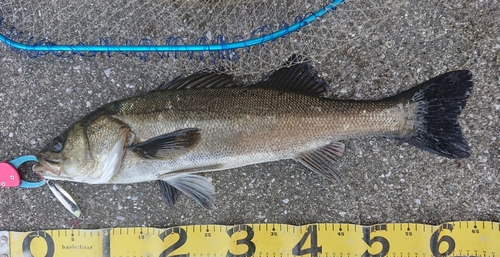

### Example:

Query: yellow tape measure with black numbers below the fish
xmin=0 ymin=221 xmax=500 ymax=257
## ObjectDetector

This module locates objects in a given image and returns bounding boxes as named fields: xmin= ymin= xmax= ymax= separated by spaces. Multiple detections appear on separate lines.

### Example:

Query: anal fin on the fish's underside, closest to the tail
xmin=295 ymin=142 xmax=345 ymax=183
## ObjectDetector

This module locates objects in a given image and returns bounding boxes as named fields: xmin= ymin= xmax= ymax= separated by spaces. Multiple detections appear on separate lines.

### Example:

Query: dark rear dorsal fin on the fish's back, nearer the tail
xmin=255 ymin=55 xmax=331 ymax=97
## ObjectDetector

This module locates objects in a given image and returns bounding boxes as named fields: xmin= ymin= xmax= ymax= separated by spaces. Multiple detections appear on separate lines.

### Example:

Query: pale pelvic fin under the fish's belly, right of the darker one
xmin=160 ymin=174 xmax=216 ymax=210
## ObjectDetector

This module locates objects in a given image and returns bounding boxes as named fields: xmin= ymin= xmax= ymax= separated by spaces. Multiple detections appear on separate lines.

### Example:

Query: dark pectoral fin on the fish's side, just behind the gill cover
xmin=129 ymin=128 xmax=201 ymax=159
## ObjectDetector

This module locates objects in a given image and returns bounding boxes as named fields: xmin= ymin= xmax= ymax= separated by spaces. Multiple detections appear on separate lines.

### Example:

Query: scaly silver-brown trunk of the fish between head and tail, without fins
xmin=108 ymin=88 xmax=406 ymax=183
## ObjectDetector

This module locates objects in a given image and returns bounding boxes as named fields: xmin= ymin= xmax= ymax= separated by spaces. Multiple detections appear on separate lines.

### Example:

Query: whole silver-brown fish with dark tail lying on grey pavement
xmin=33 ymin=57 xmax=473 ymax=210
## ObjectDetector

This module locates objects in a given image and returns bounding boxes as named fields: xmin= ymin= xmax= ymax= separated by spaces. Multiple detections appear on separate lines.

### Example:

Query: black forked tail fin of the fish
xmin=396 ymin=70 xmax=472 ymax=159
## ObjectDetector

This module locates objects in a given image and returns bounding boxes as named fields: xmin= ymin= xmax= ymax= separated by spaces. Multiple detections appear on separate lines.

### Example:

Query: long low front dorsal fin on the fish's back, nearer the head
xmin=152 ymin=72 xmax=239 ymax=92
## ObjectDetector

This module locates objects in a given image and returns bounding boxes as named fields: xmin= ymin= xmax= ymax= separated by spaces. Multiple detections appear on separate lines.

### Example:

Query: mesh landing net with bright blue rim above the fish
xmin=0 ymin=0 xmax=401 ymax=75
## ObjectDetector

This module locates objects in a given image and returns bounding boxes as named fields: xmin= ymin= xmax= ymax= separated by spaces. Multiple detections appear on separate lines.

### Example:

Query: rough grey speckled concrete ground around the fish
xmin=0 ymin=0 xmax=500 ymax=231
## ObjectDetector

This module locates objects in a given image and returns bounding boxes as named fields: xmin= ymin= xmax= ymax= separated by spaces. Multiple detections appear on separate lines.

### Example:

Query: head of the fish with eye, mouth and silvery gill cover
xmin=33 ymin=116 xmax=132 ymax=184
